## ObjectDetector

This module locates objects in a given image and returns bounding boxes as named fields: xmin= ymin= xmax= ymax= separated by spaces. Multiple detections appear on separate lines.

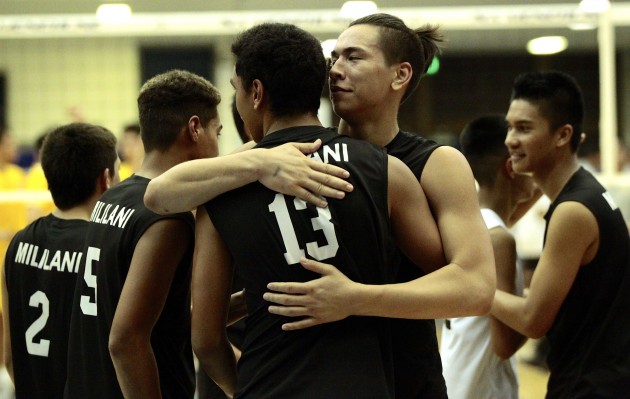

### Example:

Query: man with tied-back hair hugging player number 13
xmin=267 ymin=14 xmax=495 ymax=399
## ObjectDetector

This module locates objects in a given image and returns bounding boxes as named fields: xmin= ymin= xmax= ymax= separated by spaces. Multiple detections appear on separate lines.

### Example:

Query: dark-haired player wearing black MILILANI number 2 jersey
xmin=2 ymin=123 xmax=119 ymax=399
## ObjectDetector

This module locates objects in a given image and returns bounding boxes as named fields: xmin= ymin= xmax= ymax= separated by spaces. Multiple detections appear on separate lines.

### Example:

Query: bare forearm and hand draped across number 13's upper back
xmin=144 ymin=140 xmax=352 ymax=214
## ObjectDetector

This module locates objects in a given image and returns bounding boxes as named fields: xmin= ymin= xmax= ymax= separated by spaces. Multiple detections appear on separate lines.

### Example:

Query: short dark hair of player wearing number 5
xmin=138 ymin=70 xmax=221 ymax=152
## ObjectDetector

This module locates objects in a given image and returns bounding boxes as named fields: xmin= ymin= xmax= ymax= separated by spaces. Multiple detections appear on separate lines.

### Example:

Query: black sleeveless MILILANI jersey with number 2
xmin=4 ymin=214 xmax=88 ymax=399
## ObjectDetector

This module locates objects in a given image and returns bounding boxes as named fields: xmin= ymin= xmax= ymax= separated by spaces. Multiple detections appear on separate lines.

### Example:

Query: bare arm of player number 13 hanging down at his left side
xmin=192 ymin=207 xmax=236 ymax=398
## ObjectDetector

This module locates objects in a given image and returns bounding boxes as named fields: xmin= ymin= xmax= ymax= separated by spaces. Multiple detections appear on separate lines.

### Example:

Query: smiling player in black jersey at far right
xmin=492 ymin=71 xmax=630 ymax=398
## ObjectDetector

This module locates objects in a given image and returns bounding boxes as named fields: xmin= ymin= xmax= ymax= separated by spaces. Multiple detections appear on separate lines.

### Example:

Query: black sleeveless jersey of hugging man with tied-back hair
xmin=385 ymin=131 xmax=447 ymax=399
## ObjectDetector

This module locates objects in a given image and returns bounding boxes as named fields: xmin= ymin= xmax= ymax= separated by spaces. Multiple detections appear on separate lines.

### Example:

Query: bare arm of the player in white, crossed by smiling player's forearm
xmin=490 ymin=227 xmax=526 ymax=359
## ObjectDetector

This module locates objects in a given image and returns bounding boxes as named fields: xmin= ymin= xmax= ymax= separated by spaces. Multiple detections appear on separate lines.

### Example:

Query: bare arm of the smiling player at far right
xmin=492 ymin=202 xmax=599 ymax=338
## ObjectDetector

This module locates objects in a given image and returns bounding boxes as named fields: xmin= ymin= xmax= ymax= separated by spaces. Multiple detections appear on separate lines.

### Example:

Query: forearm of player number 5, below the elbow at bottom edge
xmin=110 ymin=341 xmax=162 ymax=398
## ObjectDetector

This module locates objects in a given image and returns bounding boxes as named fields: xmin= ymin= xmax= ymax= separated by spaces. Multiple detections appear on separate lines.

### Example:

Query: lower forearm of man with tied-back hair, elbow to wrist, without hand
xmin=348 ymin=264 xmax=494 ymax=319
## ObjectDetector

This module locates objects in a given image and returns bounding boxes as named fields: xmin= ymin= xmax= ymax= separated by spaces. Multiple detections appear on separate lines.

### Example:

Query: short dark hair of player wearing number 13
xmin=232 ymin=23 xmax=327 ymax=116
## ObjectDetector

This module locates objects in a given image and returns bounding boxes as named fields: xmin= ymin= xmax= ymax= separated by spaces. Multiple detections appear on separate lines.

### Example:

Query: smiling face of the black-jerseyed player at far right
xmin=505 ymin=99 xmax=555 ymax=174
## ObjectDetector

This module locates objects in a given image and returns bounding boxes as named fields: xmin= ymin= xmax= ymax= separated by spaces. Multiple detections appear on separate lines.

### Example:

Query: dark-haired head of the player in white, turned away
xmin=459 ymin=114 xmax=509 ymax=186
